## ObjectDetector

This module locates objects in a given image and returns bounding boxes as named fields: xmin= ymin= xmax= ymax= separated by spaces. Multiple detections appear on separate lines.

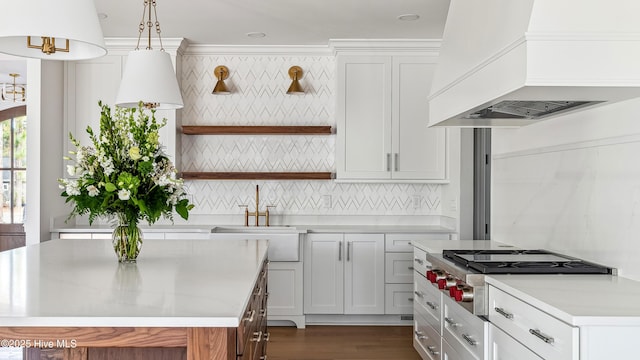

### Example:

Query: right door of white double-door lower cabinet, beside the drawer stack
xmin=344 ymin=234 xmax=384 ymax=314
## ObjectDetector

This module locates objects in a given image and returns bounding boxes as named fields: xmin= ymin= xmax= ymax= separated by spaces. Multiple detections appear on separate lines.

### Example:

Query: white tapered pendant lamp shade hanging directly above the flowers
xmin=116 ymin=50 xmax=184 ymax=109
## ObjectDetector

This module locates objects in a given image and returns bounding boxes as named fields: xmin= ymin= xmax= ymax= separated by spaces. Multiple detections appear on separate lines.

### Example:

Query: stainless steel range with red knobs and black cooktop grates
xmin=426 ymin=250 xmax=615 ymax=315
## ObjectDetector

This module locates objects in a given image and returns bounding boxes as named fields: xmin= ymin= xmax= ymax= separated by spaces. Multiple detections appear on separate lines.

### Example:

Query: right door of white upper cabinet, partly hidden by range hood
xmin=392 ymin=56 xmax=446 ymax=180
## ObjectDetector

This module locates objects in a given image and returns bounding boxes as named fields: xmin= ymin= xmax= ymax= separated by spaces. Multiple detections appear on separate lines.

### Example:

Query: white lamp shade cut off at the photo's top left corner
xmin=0 ymin=0 xmax=107 ymax=60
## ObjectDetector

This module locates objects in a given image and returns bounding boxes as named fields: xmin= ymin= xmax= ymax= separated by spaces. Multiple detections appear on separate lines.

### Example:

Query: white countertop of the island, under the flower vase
xmin=0 ymin=240 xmax=267 ymax=327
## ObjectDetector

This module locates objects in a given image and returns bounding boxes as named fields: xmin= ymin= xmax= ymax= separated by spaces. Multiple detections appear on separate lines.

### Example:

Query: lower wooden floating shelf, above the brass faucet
xmin=182 ymin=172 xmax=333 ymax=180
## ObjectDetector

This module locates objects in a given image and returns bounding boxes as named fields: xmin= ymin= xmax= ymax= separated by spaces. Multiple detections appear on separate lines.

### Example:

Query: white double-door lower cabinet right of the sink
xmin=304 ymin=233 xmax=385 ymax=315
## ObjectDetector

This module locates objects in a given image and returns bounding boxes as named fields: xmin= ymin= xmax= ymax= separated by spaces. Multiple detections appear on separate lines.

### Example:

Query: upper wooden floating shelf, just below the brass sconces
xmin=182 ymin=125 xmax=331 ymax=135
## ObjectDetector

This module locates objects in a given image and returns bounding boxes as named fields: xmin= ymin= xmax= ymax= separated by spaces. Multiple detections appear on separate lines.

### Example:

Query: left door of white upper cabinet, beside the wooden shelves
xmin=336 ymin=56 xmax=392 ymax=179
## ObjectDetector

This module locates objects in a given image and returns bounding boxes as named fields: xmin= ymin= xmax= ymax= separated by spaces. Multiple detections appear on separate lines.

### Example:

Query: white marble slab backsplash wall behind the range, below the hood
xmin=492 ymin=99 xmax=640 ymax=280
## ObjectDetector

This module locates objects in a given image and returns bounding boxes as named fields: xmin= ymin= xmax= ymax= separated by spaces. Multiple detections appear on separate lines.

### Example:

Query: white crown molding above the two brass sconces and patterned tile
xmin=183 ymin=44 xmax=332 ymax=56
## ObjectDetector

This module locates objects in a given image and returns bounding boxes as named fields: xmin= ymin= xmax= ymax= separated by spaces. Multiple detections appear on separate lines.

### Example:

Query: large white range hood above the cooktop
xmin=429 ymin=0 xmax=640 ymax=127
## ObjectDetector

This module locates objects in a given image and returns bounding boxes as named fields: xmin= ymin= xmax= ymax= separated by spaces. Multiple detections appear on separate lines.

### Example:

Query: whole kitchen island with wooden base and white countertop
xmin=0 ymin=239 xmax=268 ymax=360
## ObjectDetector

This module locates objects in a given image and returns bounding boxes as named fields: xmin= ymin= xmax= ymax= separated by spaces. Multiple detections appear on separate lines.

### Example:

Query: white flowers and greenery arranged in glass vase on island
xmin=58 ymin=102 xmax=193 ymax=256
